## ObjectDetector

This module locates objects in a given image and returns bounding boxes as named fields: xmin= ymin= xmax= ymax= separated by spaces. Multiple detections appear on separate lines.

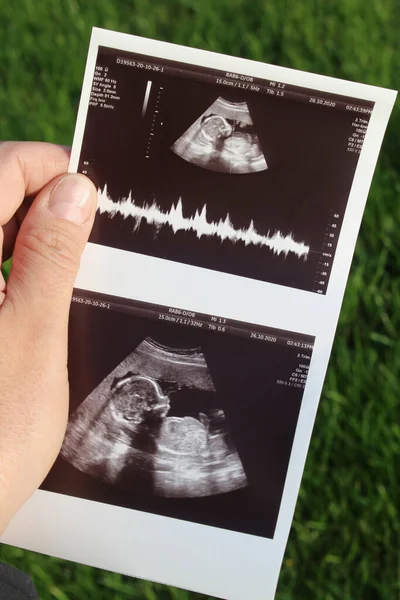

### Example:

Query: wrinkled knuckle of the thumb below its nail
xmin=24 ymin=225 xmax=79 ymax=273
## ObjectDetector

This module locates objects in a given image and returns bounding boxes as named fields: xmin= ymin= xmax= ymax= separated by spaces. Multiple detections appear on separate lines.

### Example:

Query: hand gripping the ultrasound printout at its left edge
xmin=0 ymin=142 xmax=96 ymax=533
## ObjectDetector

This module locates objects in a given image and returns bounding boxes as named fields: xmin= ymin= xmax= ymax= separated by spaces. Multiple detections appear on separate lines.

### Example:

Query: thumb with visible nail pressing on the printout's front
xmin=3 ymin=174 xmax=97 ymax=326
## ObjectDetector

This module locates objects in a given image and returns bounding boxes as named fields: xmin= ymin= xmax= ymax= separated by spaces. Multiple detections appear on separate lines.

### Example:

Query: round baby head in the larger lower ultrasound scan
xmin=110 ymin=374 xmax=170 ymax=425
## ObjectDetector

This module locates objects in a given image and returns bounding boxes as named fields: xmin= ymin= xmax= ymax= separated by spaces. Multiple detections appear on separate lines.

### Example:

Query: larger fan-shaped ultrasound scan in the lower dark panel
xmin=61 ymin=338 xmax=247 ymax=498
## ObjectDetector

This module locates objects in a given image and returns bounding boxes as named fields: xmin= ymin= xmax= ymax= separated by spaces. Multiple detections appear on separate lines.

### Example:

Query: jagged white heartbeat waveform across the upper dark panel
xmin=97 ymin=185 xmax=310 ymax=260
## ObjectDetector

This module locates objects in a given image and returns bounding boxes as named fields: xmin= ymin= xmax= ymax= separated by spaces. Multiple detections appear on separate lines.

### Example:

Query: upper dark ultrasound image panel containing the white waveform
xmin=72 ymin=47 xmax=382 ymax=294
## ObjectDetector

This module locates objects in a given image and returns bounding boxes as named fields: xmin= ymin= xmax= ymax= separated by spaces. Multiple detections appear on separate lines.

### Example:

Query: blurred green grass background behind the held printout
xmin=0 ymin=0 xmax=400 ymax=600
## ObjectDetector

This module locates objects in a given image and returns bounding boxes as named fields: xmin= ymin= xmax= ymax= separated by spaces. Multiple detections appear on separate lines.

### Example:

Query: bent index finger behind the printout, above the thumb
xmin=0 ymin=142 xmax=70 ymax=226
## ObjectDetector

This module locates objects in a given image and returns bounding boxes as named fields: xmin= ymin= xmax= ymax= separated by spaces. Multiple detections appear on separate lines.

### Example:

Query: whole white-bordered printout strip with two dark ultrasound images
xmin=3 ymin=29 xmax=396 ymax=600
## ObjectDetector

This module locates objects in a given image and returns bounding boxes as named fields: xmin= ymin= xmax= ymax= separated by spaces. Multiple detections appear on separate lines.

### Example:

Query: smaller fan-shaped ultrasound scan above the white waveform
xmin=171 ymin=97 xmax=267 ymax=174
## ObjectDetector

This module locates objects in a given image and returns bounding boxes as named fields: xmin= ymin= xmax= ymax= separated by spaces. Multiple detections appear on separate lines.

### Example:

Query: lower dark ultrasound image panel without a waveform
xmin=43 ymin=298 xmax=314 ymax=538
